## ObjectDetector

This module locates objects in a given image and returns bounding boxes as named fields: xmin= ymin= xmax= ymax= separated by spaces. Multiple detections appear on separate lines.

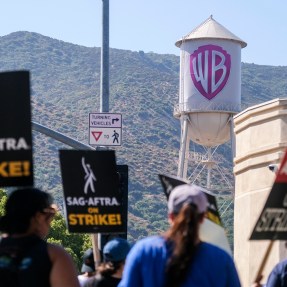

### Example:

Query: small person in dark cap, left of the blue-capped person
xmin=78 ymin=248 xmax=96 ymax=287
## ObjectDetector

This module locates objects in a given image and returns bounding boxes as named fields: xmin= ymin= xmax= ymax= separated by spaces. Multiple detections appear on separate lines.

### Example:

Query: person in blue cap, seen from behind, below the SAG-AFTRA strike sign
xmin=94 ymin=238 xmax=130 ymax=287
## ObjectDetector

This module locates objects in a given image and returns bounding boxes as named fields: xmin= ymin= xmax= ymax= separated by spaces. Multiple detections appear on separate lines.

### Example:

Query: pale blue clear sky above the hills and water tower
xmin=0 ymin=0 xmax=287 ymax=66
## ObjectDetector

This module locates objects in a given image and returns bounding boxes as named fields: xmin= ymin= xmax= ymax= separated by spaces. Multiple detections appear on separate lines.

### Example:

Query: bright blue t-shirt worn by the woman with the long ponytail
xmin=118 ymin=236 xmax=241 ymax=287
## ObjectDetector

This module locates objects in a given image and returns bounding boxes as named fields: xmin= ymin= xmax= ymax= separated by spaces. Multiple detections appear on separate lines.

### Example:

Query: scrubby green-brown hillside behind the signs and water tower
xmin=0 ymin=32 xmax=287 ymax=245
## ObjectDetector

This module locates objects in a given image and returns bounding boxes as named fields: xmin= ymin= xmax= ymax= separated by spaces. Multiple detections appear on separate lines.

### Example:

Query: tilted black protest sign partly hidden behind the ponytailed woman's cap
xmin=158 ymin=174 xmax=221 ymax=225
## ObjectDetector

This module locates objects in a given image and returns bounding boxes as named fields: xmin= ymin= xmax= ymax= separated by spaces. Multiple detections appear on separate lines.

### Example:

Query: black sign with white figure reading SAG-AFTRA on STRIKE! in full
xmin=60 ymin=150 xmax=126 ymax=233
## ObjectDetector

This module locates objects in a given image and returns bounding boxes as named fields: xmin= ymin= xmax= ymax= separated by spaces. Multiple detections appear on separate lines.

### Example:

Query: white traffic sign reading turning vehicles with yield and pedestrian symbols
xmin=89 ymin=113 xmax=122 ymax=146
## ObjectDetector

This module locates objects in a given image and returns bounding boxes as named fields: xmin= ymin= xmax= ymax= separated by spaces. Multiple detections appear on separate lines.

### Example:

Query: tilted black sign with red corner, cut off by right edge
xmin=250 ymin=153 xmax=287 ymax=240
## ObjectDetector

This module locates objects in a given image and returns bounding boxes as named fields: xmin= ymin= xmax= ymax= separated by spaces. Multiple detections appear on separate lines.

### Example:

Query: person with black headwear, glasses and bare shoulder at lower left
xmin=0 ymin=188 xmax=80 ymax=287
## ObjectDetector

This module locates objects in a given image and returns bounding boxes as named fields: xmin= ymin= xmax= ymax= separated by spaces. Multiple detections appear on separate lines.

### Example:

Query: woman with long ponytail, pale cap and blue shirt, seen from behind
xmin=119 ymin=184 xmax=241 ymax=287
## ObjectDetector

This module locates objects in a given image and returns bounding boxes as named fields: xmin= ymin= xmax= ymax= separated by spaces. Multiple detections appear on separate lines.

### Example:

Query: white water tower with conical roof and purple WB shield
xmin=174 ymin=16 xmax=247 ymax=192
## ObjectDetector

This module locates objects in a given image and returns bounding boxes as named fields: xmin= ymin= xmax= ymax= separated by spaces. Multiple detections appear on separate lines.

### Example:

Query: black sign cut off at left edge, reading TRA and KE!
xmin=0 ymin=71 xmax=33 ymax=187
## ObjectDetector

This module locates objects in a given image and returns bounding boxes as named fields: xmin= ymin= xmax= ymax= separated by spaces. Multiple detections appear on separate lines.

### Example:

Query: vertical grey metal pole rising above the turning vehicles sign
xmin=100 ymin=0 xmax=110 ymax=113
